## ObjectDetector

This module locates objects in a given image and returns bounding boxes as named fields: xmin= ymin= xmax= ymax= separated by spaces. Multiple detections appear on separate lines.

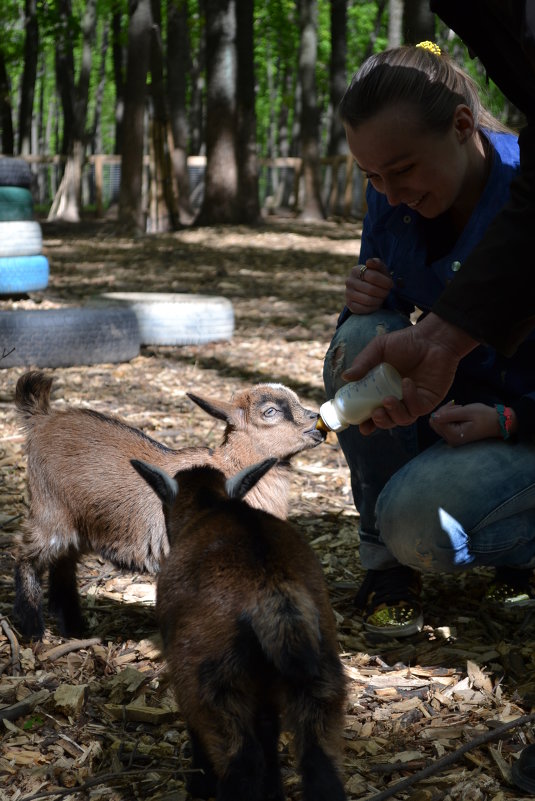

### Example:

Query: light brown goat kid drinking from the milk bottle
xmin=14 ymin=371 xmax=323 ymax=638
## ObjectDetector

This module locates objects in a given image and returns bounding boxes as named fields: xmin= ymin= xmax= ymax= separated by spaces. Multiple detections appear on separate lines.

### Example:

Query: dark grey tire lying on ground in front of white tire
xmin=0 ymin=307 xmax=140 ymax=368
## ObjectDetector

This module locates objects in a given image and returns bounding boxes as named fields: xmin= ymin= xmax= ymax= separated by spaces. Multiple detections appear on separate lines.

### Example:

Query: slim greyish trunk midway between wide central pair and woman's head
xmin=299 ymin=0 xmax=325 ymax=220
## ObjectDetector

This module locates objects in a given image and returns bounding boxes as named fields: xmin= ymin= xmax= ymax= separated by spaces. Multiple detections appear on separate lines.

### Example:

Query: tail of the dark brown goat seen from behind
xmin=248 ymin=583 xmax=321 ymax=681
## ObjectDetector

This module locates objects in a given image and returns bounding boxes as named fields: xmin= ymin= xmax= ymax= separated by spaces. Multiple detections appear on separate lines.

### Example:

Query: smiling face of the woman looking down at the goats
xmin=346 ymin=103 xmax=480 ymax=218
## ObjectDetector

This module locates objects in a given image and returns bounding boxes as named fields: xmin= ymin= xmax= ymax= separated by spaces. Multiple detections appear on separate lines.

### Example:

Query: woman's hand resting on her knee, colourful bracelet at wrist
xmin=429 ymin=403 xmax=516 ymax=448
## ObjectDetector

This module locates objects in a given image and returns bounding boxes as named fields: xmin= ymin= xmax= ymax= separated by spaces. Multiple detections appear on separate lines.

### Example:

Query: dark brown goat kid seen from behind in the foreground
xmin=133 ymin=460 xmax=346 ymax=801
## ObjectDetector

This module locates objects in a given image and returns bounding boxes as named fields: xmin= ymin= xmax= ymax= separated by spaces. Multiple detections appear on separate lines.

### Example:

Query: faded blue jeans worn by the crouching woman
xmin=323 ymin=310 xmax=535 ymax=573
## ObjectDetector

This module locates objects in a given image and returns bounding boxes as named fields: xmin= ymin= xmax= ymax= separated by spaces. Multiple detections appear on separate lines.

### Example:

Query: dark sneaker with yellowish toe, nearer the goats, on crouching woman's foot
xmin=355 ymin=565 xmax=424 ymax=637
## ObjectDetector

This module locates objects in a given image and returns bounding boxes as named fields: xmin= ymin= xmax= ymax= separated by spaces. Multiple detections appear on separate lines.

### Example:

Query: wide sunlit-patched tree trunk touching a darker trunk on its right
xmin=196 ymin=0 xmax=240 ymax=225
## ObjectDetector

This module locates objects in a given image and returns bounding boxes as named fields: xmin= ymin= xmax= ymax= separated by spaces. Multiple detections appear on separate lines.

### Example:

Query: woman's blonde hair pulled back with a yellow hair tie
xmin=339 ymin=45 xmax=510 ymax=133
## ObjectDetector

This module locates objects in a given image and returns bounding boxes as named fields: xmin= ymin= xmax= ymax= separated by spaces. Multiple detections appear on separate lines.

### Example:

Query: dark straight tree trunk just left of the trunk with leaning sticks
xmin=119 ymin=0 xmax=152 ymax=231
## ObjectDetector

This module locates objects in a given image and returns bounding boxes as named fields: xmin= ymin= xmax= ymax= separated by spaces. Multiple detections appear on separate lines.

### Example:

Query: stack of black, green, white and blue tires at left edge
xmin=0 ymin=157 xmax=49 ymax=295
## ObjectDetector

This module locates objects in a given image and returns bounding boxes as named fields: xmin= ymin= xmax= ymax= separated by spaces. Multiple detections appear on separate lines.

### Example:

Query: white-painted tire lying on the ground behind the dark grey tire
xmin=101 ymin=292 xmax=234 ymax=345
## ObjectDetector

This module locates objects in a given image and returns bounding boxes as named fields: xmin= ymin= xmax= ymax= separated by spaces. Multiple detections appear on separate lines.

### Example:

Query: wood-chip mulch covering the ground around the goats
xmin=0 ymin=218 xmax=535 ymax=801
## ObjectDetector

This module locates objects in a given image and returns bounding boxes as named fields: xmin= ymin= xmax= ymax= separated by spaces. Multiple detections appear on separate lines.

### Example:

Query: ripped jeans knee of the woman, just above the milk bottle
xmin=323 ymin=309 xmax=409 ymax=395
